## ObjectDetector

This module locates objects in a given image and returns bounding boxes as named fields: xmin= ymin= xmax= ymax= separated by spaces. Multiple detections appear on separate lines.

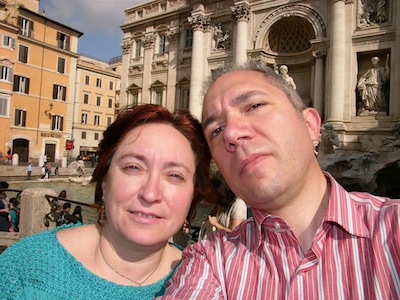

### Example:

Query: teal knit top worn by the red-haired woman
xmin=0 ymin=225 xmax=178 ymax=300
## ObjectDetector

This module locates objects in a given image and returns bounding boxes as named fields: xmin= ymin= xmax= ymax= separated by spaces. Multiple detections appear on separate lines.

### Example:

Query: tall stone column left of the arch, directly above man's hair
xmin=232 ymin=1 xmax=250 ymax=63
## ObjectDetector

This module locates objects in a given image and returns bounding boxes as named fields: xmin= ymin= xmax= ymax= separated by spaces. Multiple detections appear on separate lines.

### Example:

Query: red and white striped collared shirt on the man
xmin=160 ymin=174 xmax=400 ymax=300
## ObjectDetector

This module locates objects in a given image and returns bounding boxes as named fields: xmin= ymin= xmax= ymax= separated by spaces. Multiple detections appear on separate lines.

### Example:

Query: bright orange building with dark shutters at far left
xmin=0 ymin=1 xmax=82 ymax=164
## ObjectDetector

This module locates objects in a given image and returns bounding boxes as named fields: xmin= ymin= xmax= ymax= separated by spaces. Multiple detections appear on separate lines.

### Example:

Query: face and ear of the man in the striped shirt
xmin=203 ymin=71 xmax=320 ymax=211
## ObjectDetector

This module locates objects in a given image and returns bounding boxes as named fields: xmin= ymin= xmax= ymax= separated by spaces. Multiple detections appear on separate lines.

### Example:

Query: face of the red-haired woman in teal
xmin=102 ymin=124 xmax=196 ymax=246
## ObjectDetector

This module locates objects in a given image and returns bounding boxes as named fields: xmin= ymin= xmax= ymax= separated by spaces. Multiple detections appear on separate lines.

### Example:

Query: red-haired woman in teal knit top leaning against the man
xmin=0 ymin=105 xmax=210 ymax=299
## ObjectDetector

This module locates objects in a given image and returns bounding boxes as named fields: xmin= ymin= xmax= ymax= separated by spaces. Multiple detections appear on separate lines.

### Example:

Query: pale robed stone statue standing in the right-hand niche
xmin=357 ymin=54 xmax=389 ymax=115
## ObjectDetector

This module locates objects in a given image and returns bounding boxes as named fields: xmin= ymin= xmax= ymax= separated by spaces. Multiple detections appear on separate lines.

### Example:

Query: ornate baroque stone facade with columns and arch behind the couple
xmin=121 ymin=0 xmax=400 ymax=195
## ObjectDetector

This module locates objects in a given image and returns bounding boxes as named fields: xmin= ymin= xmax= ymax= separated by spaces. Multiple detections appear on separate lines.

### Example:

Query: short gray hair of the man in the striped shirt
xmin=202 ymin=60 xmax=306 ymax=113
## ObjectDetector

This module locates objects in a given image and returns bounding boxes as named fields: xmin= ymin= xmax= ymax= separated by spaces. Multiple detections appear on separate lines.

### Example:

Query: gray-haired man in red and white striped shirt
xmin=160 ymin=62 xmax=400 ymax=299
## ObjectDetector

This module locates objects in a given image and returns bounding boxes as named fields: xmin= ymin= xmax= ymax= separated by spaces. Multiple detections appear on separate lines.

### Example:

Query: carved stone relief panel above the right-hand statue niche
xmin=359 ymin=0 xmax=389 ymax=27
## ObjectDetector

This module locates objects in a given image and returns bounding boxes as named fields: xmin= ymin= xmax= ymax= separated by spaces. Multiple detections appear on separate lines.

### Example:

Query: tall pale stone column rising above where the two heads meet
xmin=188 ymin=5 xmax=211 ymax=120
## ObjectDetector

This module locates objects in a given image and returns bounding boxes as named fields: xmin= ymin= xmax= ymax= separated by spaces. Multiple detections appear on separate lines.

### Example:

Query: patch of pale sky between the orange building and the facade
xmin=39 ymin=0 xmax=145 ymax=62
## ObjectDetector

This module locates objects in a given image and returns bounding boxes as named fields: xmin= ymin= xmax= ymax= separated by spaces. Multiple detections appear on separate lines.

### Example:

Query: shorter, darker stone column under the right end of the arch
xmin=313 ymin=51 xmax=326 ymax=119
